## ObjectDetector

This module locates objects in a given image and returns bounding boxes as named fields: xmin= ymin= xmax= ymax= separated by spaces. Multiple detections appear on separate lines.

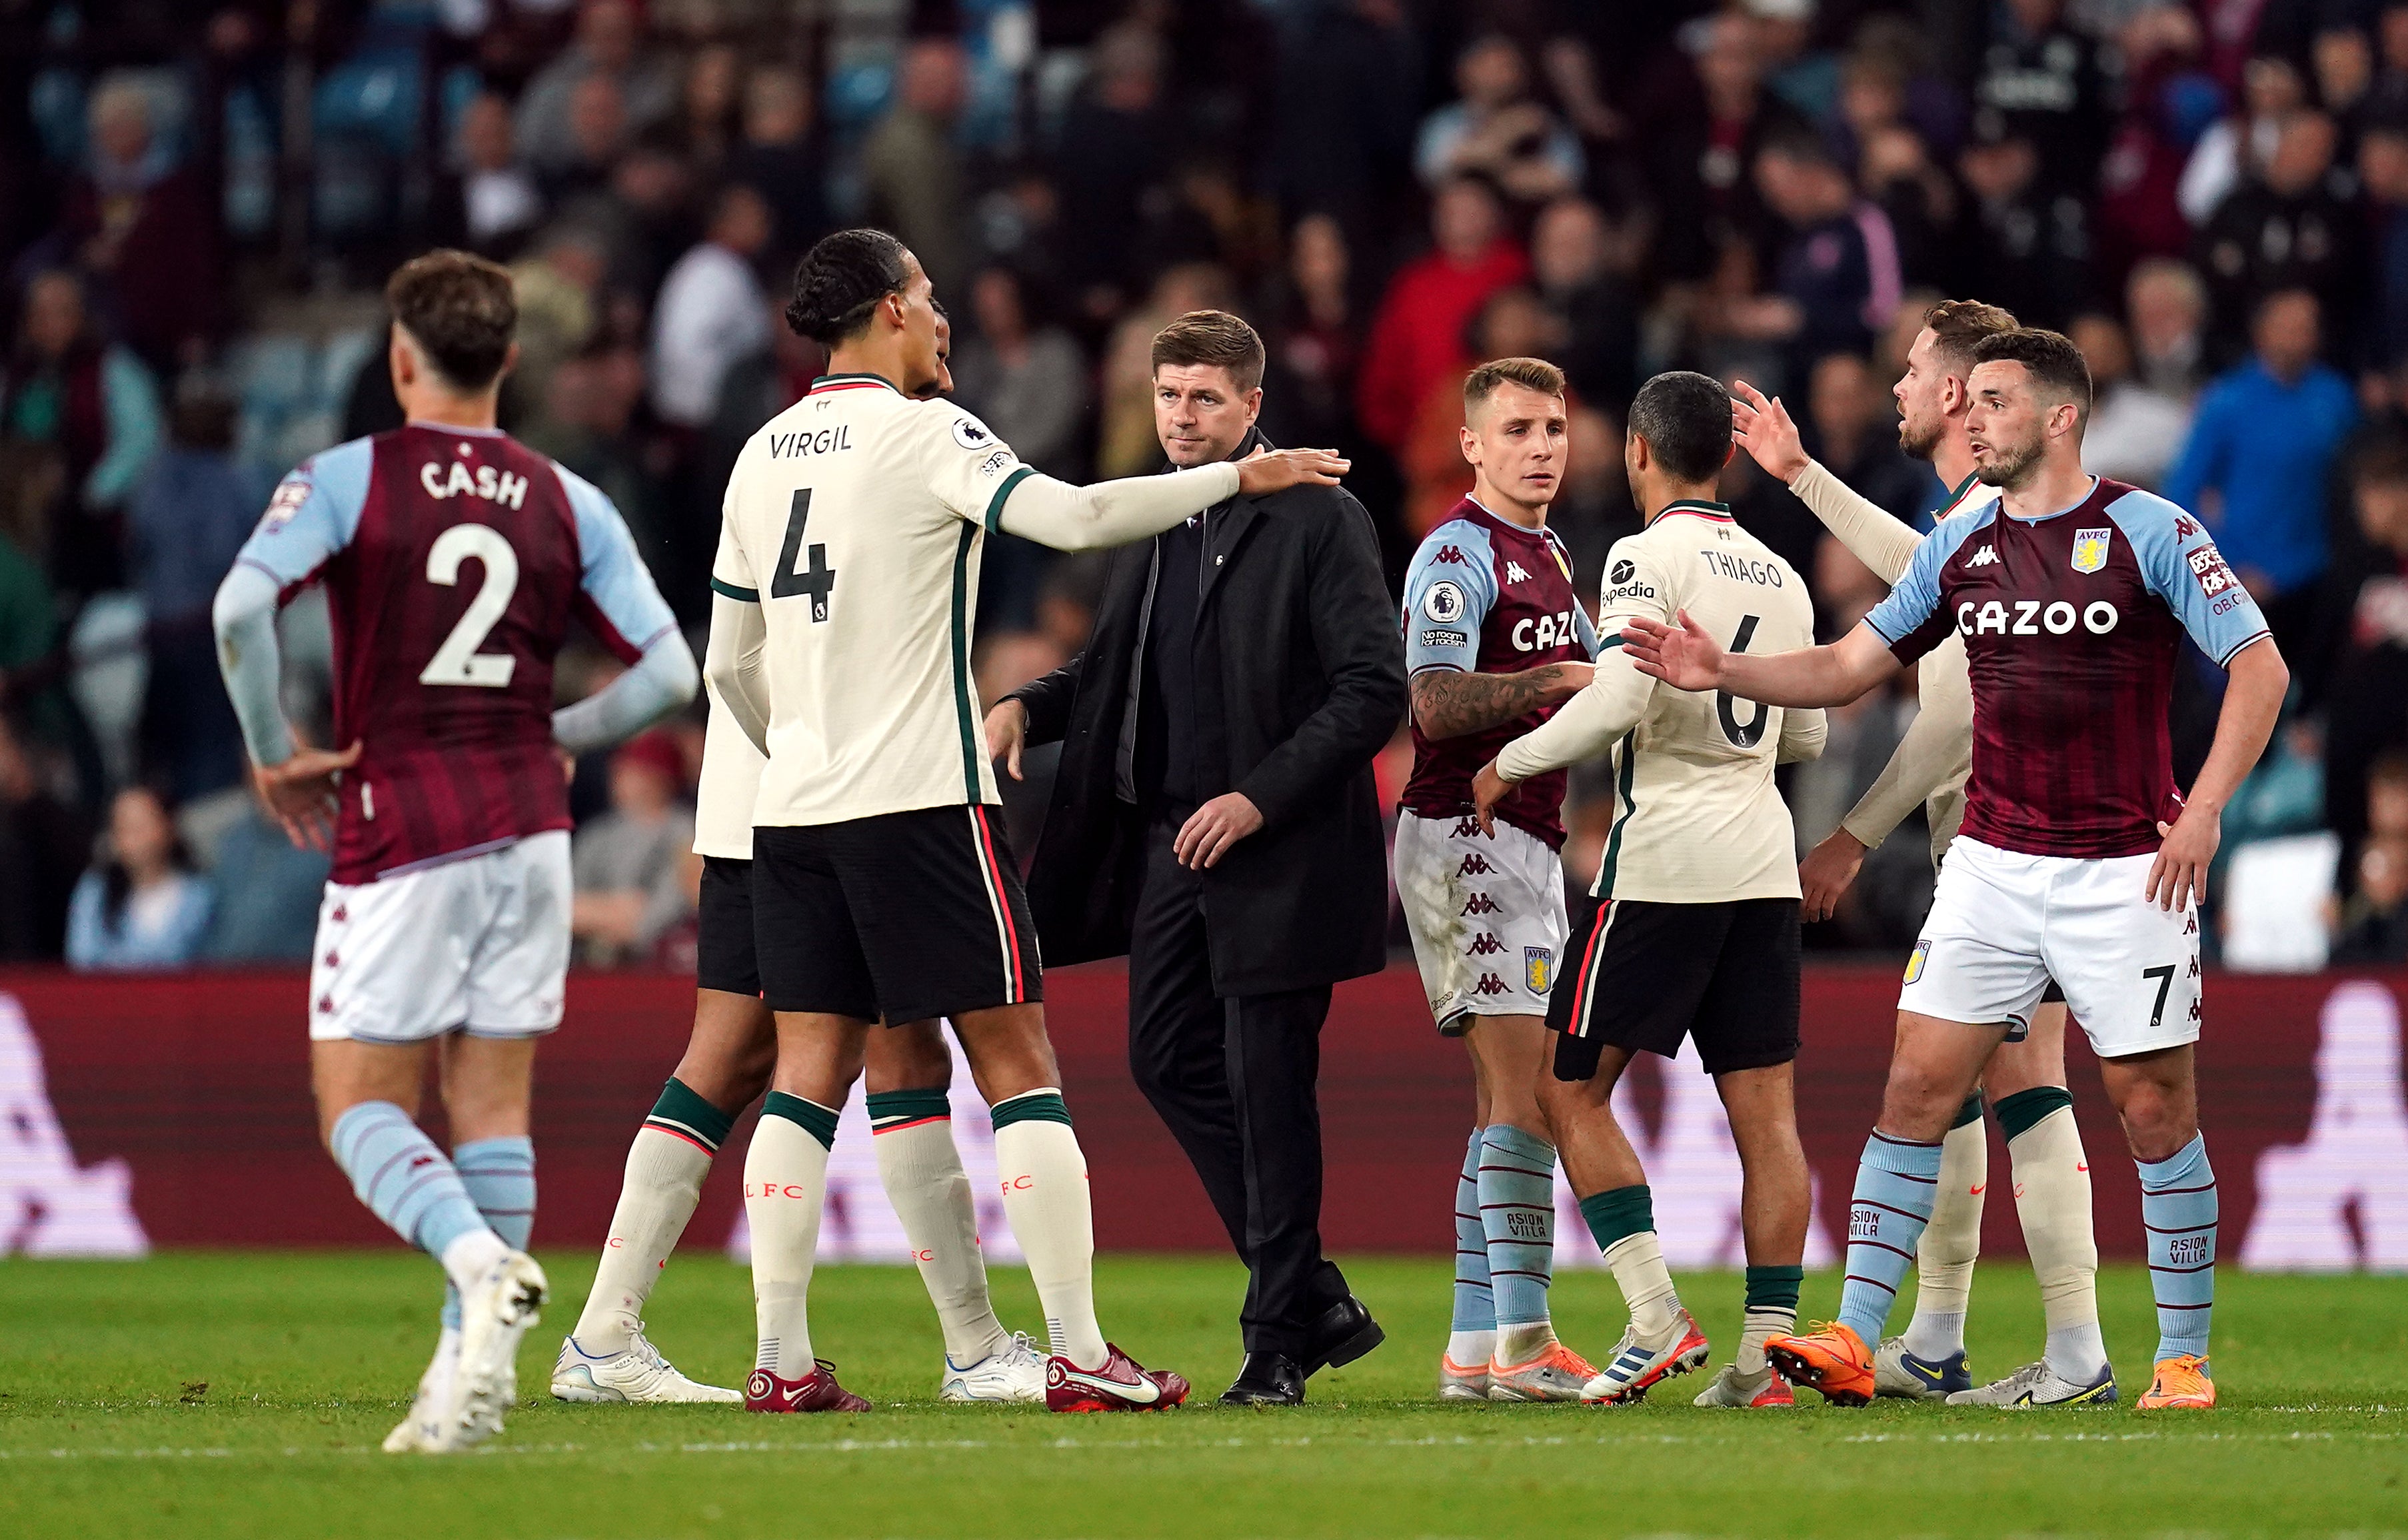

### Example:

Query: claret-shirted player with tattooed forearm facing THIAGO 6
xmin=1394 ymin=359 xmax=1596 ymax=1401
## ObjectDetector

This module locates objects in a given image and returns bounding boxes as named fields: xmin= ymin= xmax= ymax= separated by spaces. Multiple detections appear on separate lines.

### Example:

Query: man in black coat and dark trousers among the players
xmin=987 ymin=311 xmax=1406 ymax=1405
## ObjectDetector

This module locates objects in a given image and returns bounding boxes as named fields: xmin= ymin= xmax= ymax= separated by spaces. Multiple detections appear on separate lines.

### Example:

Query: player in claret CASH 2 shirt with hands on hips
xmin=215 ymin=251 xmax=696 ymax=1453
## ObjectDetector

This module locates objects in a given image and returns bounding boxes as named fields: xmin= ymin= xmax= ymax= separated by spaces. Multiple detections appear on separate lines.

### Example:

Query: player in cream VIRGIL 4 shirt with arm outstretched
xmin=706 ymin=231 xmax=1346 ymax=1413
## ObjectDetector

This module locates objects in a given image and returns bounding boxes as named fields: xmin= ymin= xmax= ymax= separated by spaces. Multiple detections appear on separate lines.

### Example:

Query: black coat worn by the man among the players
xmin=1009 ymin=433 xmax=1406 ymax=996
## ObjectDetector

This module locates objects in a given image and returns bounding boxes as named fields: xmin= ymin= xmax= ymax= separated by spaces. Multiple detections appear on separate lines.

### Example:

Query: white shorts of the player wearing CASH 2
xmin=308 ymin=830 xmax=573 ymax=1042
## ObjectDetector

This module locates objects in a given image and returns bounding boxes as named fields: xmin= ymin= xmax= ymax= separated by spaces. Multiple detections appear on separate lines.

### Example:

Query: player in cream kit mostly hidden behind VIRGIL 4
xmin=551 ymin=315 xmax=1045 ymax=1413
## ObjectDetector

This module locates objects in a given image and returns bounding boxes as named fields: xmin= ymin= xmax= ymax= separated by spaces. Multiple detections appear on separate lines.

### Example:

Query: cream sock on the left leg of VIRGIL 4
xmin=744 ymin=1090 xmax=836 ymax=1379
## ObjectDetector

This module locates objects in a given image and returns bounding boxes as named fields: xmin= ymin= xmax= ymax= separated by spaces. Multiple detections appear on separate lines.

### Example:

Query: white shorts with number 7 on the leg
xmin=1897 ymin=835 xmax=2199 ymax=1059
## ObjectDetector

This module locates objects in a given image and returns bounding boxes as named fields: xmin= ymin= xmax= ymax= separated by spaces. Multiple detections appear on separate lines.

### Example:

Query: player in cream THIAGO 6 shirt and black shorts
xmin=1472 ymin=371 xmax=1825 ymax=1407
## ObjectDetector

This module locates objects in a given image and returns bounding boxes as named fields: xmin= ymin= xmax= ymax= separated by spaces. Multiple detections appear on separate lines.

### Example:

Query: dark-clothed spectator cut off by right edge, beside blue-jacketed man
xmin=2307 ymin=438 xmax=2408 ymax=850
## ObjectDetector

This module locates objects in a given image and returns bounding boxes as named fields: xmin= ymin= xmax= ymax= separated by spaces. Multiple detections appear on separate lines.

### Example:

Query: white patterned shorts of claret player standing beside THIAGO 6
xmin=1397 ymin=811 xmax=1570 ymax=1037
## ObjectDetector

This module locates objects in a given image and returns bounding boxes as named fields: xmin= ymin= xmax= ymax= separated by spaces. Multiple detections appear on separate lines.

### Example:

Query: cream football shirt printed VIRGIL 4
xmin=706 ymin=375 xmax=1036 ymax=828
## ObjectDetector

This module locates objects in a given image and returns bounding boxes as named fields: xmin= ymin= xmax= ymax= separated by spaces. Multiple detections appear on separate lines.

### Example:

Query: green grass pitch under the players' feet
xmin=0 ymin=1251 xmax=2408 ymax=1540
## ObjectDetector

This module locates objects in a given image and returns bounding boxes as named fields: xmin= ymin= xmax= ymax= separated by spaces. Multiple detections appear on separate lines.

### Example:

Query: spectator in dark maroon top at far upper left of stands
xmin=55 ymin=77 xmax=224 ymax=373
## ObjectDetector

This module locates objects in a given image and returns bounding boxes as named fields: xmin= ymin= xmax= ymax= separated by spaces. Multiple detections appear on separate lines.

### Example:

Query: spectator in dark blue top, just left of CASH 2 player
xmin=127 ymin=378 xmax=270 ymax=801
